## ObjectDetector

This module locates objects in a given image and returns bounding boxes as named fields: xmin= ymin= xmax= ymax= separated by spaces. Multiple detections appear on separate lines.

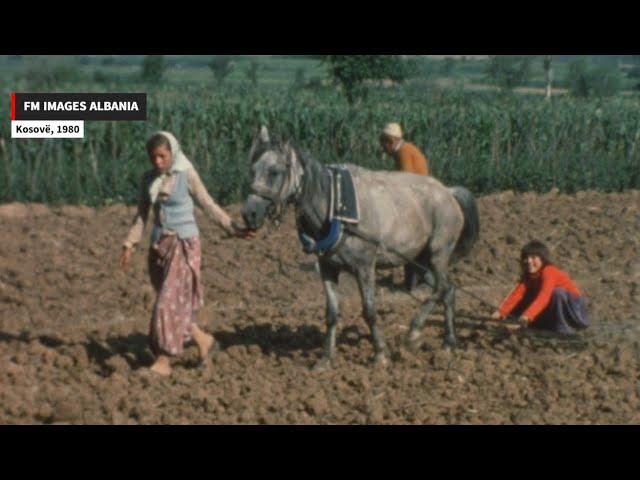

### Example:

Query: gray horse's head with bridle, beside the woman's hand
xmin=242 ymin=126 xmax=303 ymax=229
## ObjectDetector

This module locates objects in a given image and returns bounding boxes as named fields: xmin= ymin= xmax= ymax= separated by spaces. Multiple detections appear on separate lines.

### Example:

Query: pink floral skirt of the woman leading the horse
xmin=149 ymin=235 xmax=203 ymax=355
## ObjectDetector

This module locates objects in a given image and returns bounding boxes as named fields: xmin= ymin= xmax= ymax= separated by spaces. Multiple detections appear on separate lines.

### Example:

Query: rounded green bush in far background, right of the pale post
xmin=565 ymin=60 xmax=622 ymax=98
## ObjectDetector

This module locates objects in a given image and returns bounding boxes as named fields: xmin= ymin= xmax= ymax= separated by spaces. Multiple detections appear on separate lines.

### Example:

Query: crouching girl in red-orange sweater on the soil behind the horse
xmin=492 ymin=240 xmax=589 ymax=335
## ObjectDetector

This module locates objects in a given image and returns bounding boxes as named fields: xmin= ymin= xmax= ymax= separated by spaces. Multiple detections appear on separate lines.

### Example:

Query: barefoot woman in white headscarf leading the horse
xmin=119 ymin=132 xmax=251 ymax=376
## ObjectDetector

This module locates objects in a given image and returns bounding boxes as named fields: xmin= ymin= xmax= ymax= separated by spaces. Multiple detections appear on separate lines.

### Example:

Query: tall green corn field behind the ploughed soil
xmin=0 ymin=86 xmax=640 ymax=205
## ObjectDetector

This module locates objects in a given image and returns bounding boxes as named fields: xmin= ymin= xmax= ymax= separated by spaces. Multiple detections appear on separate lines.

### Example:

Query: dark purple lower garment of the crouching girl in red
xmin=511 ymin=288 xmax=589 ymax=334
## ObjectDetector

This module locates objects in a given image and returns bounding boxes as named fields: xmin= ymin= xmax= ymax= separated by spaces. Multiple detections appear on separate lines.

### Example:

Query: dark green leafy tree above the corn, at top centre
xmin=324 ymin=55 xmax=414 ymax=103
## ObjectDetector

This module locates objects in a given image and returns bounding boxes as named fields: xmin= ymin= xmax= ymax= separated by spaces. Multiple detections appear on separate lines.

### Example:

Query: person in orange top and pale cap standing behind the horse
xmin=380 ymin=123 xmax=429 ymax=291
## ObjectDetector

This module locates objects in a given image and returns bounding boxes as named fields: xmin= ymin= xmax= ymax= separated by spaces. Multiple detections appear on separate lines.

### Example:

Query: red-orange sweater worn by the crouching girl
xmin=500 ymin=265 xmax=581 ymax=322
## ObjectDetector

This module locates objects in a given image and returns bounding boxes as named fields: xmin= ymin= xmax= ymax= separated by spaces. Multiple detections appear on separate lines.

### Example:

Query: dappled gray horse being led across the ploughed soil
xmin=242 ymin=126 xmax=479 ymax=370
